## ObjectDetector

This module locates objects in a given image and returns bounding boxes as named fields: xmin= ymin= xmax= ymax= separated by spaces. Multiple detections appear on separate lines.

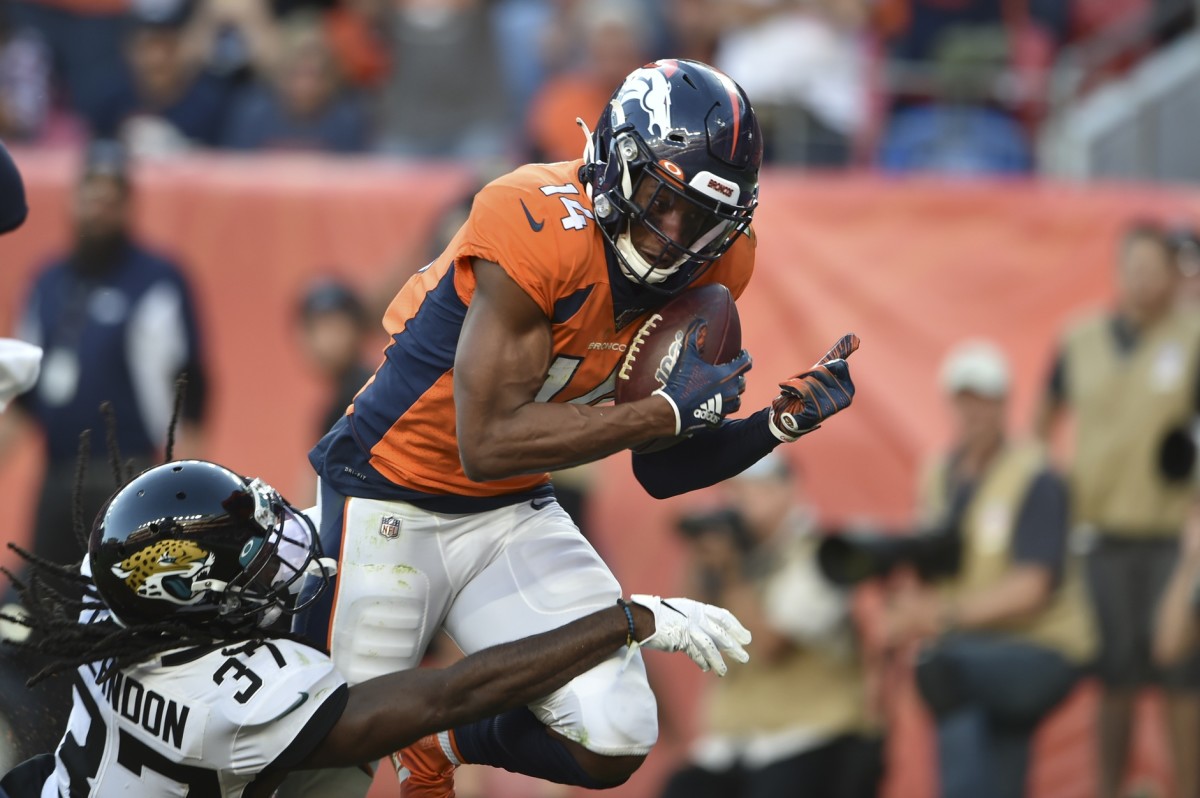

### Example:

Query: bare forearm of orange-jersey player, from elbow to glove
xmin=458 ymin=396 xmax=674 ymax=481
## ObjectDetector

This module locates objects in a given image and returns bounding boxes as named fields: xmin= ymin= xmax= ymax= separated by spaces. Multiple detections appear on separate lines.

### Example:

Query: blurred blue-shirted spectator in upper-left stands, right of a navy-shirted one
xmin=221 ymin=12 xmax=368 ymax=152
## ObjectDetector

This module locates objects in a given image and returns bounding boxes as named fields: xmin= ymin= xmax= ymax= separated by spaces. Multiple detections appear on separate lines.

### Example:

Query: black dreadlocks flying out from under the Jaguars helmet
xmin=0 ymin=391 xmax=311 ymax=686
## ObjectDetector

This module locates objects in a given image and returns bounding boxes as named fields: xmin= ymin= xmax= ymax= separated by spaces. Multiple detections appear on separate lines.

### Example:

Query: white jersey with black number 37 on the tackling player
xmin=42 ymin=640 xmax=347 ymax=798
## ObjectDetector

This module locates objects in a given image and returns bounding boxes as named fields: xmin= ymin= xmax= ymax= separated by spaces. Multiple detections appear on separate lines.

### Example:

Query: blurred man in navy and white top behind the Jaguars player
xmin=0 ymin=142 xmax=205 ymax=573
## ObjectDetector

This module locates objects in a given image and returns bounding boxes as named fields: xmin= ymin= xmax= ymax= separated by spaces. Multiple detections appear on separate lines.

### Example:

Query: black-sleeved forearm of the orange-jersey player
xmin=634 ymin=409 xmax=780 ymax=499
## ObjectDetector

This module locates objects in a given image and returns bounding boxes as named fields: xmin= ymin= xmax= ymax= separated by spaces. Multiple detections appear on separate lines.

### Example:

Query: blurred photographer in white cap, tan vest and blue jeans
xmin=883 ymin=342 xmax=1094 ymax=798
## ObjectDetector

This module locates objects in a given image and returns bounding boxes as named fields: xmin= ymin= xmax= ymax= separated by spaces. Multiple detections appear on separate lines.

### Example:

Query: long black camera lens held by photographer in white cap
xmin=817 ymin=527 xmax=962 ymax=586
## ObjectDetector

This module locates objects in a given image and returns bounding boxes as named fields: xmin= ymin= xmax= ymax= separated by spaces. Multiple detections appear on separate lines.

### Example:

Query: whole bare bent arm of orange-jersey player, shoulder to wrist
xmin=454 ymin=260 xmax=676 ymax=481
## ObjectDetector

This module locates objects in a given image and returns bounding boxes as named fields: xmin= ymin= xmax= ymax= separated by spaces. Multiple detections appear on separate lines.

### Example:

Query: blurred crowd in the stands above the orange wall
xmin=0 ymin=0 xmax=1194 ymax=173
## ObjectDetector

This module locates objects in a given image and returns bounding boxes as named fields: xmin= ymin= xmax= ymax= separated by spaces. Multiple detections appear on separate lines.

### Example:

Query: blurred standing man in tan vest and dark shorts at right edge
xmin=1037 ymin=222 xmax=1200 ymax=798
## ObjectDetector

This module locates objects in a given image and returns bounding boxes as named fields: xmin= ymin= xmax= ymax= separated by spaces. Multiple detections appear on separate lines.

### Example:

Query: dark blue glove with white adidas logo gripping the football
xmin=653 ymin=319 xmax=751 ymax=436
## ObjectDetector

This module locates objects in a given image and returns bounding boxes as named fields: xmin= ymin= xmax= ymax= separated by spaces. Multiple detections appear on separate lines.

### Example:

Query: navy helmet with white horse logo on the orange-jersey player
xmin=581 ymin=59 xmax=762 ymax=295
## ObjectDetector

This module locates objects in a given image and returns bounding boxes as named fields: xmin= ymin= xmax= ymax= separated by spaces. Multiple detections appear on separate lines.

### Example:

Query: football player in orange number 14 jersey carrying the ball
xmin=284 ymin=60 xmax=853 ymax=798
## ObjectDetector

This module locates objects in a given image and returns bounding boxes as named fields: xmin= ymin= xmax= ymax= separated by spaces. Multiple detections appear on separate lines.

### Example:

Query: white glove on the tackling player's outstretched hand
xmin=629 ymin=595 xmax=750 ymax=676
